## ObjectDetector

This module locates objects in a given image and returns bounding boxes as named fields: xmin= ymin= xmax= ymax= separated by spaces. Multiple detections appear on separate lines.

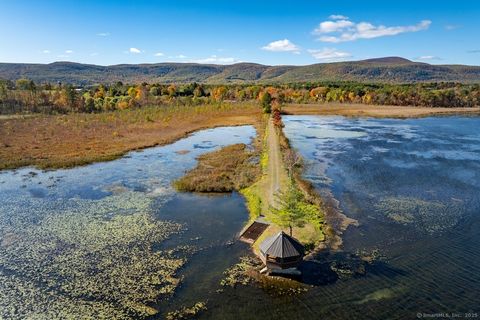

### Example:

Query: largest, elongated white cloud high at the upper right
xmin=313 ymin=17 xmax=432 ymax=43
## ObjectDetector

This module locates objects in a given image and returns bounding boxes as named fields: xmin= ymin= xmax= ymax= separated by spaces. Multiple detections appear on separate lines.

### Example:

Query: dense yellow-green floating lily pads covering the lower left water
xmin=0 ymin=191 xmax=188 ymax=319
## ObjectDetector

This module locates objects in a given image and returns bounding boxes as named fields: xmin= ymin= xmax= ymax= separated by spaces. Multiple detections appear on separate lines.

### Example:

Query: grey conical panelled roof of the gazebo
xmin=260 ymin=231 xmax=305 ymax=258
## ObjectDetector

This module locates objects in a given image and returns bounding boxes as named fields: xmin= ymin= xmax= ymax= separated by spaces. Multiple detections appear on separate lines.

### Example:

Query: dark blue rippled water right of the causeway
xmin=204 ymin=116 xmax=480 ymax=319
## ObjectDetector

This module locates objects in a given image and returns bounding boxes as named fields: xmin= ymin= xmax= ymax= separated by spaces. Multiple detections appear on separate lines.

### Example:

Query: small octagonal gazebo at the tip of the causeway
xmin=260 ymin=231 xmax=305 ymax=270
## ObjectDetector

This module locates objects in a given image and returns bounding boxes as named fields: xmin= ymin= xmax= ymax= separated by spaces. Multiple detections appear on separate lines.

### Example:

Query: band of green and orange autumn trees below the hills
xmin=0 ymin=79 xmax=480 ymax=113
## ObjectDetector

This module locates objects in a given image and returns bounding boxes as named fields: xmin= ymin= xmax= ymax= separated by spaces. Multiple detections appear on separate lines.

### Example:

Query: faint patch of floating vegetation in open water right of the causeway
xmin=375 ymin=197 xmax=465 ymax=233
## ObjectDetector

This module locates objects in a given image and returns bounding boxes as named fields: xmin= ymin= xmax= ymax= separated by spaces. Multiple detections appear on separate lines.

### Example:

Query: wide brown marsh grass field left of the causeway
xmin=0 ymin=103 xmax=261 ymax=169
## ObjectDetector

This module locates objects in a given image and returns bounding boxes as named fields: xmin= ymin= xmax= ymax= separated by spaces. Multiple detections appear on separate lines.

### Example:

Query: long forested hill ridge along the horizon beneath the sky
xmin=0 ymin=57 xmax=480 ymax=85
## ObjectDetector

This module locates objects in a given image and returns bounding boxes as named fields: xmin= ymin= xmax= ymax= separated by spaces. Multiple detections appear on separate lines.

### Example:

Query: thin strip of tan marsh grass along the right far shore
xmin=282 ymin=103 xmax=480 ymax=118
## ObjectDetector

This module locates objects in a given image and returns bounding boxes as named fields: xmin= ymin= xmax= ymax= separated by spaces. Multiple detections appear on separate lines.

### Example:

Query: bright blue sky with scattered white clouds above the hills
xmin=0 ymin=0 xmax=480 ymax=65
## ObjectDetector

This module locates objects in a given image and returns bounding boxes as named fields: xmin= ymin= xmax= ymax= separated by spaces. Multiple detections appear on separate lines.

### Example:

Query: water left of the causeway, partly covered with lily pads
xmin=0 ymin=126 xmax=255 ymax=319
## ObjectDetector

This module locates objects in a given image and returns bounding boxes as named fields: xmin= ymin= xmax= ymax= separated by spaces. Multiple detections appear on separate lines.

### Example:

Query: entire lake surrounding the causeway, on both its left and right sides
xmin=0 ymin=116 xmax=480 ymax=319
